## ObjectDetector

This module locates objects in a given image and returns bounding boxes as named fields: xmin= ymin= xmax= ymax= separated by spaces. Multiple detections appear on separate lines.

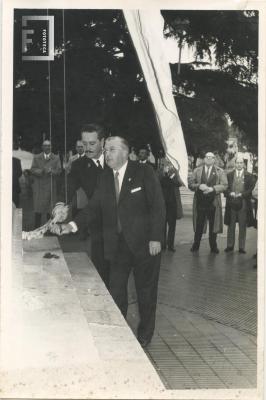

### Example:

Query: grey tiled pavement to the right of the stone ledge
xmin=19 ymin=189 xmax=257 ymax=389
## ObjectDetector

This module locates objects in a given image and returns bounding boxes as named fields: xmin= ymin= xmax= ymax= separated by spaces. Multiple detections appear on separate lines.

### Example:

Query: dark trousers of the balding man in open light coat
xmin=194 ymin=207 xmax=217 ymax=249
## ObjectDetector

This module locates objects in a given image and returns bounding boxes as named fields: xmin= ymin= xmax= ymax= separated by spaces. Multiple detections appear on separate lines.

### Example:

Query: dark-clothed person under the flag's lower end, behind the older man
xmin=158 ymin=161 xmax=183 ymax=252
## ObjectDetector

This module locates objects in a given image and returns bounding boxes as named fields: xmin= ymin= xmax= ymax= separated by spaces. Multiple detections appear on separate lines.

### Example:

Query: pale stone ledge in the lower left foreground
xmin=0 ymin=211 xmax=165 ymax=399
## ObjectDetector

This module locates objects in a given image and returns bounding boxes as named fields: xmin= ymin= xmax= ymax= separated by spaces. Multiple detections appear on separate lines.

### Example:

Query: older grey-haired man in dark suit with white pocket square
xmin=59 ymin=136 xmax=165 ymax=346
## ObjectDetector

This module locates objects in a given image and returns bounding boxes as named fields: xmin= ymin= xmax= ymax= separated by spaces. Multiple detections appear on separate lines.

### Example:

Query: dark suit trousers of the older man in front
xmin=109 ymin=233 xmax=161 ymax=339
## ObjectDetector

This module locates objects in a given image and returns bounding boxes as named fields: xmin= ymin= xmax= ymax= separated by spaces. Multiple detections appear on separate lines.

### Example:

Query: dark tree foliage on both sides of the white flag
xmin=13 ymin=10 xmax=258 ymax=152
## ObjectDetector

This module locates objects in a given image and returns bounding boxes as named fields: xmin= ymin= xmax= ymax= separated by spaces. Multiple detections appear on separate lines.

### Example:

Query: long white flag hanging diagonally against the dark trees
xmin=123 ymin=9 xmax=188 ymax=186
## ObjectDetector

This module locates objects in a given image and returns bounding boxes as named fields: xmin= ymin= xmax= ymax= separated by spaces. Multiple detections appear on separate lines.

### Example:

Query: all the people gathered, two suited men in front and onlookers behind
xmin=13 ymin=124 xmax=258 ymax=347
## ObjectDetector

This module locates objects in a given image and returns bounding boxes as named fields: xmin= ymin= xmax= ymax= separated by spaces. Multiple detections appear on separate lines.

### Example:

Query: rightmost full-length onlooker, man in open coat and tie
xmin=224 ymin=157 xmax=255 ymax=254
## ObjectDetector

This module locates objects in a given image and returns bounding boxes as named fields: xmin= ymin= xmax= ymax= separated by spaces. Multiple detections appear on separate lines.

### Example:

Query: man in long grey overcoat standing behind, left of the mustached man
xmin=30 ymin=140 xmax=61 ymax=228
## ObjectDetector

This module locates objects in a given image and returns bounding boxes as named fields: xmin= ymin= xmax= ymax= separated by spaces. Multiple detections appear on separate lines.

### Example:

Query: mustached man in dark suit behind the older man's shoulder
xmin=59 ymin=124 xmax=109 ymax=287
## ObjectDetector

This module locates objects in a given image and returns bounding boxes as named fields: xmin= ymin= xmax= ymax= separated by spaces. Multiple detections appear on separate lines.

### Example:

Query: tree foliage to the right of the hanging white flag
xmin=163 ymin=11 xmax=258 ymax=153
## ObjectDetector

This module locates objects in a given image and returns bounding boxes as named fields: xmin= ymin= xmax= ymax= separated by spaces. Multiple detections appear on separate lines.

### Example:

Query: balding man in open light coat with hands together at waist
xmin=188 ymin=152 xmax=227 ymax=254
